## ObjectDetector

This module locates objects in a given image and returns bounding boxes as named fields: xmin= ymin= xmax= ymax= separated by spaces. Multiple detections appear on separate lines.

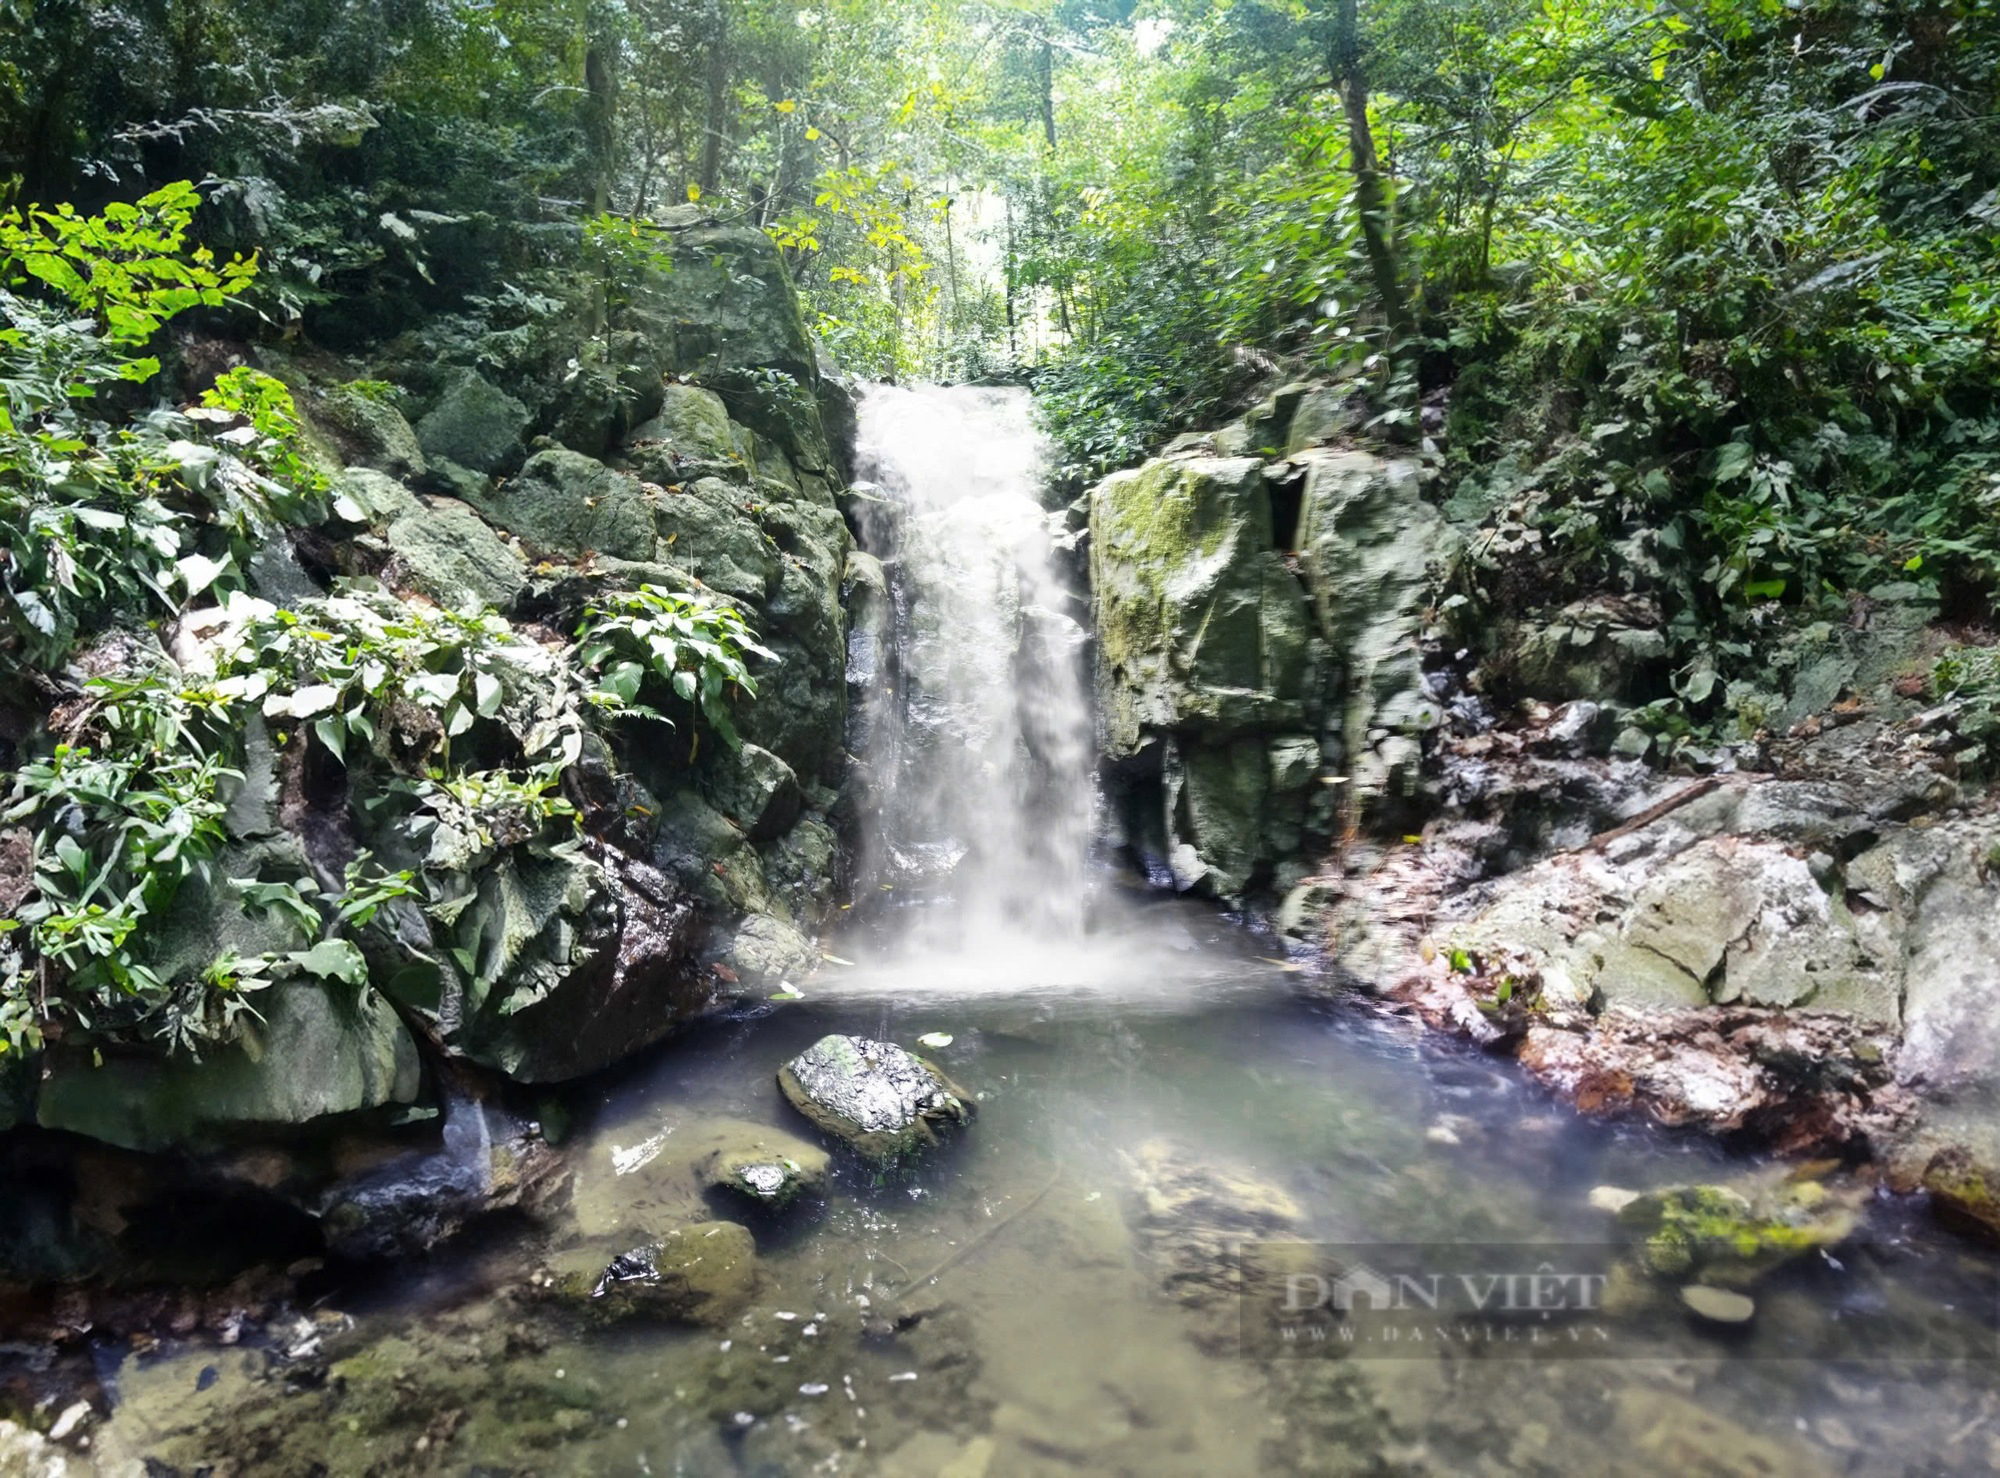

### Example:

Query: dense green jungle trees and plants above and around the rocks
xmin=0 ymin=0 xmax=2000 ymax=1040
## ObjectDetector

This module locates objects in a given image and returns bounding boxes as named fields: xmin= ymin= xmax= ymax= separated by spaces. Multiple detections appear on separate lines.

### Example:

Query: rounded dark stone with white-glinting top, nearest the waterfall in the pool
xmin=778 ymin=1036 xmax=974 ymax=1164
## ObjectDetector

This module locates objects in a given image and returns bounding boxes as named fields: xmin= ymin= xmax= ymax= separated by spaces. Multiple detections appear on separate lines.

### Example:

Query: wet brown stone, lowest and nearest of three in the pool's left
xmin=542 ymin=1222 xmax=758 ymax=1326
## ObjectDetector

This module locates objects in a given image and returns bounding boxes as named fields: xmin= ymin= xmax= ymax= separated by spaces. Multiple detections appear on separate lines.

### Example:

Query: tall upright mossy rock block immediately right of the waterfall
xmin=1088 ymin=386 xmax=1452 ymax=900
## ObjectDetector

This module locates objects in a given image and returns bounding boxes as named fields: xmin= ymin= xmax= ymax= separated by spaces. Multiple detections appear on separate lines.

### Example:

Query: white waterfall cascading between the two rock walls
xmin=848 ymin=386 xmax=1094 ymax=954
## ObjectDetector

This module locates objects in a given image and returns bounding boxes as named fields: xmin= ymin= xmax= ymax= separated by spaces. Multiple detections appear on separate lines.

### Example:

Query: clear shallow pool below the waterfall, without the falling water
xmin=86 ymin=884 xmax=2000 ymax=1476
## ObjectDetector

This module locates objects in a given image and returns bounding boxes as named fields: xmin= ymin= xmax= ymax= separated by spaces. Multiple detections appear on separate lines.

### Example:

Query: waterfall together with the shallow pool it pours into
xmin=82 ymin=390 xmax=2000 ymax=1478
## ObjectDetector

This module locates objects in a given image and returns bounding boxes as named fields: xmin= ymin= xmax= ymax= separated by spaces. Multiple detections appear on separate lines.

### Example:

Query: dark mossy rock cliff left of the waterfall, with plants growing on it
xmin=0 ymin=212 xmax=852 ymax=1246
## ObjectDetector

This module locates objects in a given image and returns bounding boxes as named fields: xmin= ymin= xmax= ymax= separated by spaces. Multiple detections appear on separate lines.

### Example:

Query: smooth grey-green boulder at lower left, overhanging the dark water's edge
xmin=36 ymin=980 xmax=422 ymax=1150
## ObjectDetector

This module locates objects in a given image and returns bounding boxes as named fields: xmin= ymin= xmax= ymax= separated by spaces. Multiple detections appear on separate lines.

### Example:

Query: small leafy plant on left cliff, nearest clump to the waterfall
xmin=576 ymin=584 xmax=778 ymax=748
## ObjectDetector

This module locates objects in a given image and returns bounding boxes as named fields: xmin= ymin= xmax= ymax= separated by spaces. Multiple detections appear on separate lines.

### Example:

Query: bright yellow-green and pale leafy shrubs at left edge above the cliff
xmin=0 ymin=186 xmax=318 ymax=666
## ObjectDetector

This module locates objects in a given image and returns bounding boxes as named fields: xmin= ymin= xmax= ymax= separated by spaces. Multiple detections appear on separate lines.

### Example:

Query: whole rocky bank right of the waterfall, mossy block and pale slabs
xmin=1088 ymin=386 xmax=2000 ymax=1236
